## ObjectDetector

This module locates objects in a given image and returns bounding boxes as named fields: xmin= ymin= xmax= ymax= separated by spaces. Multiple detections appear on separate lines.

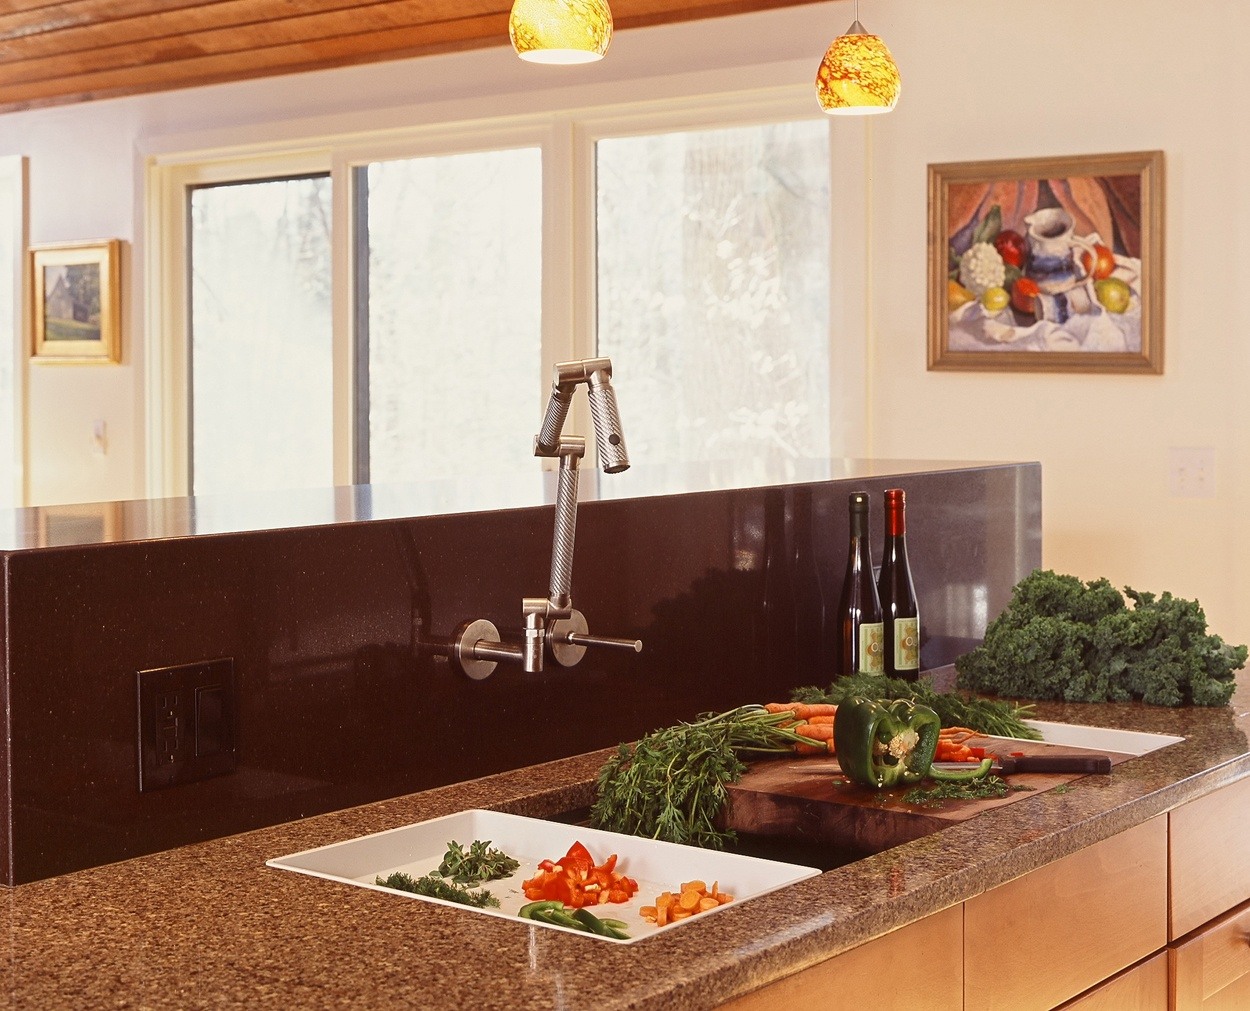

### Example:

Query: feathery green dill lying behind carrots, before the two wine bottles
xmin=791 ymin=674 xmax=1041 ymax=740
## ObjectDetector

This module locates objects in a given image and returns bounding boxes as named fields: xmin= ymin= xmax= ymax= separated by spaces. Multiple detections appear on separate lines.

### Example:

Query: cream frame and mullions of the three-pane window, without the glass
xmin=144 ymin=85 xmax=850 ymax=497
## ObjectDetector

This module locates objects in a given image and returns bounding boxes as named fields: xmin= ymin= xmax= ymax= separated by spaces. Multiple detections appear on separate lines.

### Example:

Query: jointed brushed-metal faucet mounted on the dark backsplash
xmin=449 ymin=359 xmax=643 ymax=680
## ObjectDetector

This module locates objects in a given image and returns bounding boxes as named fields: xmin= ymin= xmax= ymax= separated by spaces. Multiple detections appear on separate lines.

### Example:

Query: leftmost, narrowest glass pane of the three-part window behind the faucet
xmin=189 ymin=175 xmax=334 ymax=495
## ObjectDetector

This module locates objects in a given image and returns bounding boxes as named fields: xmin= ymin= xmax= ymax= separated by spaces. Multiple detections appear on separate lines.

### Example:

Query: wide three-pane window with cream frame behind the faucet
xmin=149 ymin=91 xmax=839 ymax=494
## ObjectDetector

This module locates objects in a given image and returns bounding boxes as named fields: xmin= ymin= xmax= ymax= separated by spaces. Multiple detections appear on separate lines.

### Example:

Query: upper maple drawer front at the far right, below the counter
xmin=1168 ymin=779 xmax=1250 ymax=941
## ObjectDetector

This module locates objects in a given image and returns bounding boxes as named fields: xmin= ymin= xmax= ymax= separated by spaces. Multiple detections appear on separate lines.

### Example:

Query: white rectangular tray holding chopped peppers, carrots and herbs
xmin=265 ymin=810 xmax=820 ymax=945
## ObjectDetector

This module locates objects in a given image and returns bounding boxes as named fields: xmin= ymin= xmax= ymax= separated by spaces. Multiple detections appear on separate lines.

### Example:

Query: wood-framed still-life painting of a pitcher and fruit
xmin=928 ymin=151 xmax=1164 ymax=375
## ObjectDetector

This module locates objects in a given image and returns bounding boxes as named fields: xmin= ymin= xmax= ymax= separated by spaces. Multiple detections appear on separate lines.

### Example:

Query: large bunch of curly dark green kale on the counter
xmin=955 ymin=569 xmax=1246 ymax=706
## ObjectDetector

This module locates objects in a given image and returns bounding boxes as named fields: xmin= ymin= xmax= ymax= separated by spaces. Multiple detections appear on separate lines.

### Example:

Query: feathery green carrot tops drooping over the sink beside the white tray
xmin=590 ymin=705 xmax=811 ymax=850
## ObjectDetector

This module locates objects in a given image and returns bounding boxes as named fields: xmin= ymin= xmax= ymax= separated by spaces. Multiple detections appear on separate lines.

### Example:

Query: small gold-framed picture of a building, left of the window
xmin=30 ymin=239 xmax=121 ymax=364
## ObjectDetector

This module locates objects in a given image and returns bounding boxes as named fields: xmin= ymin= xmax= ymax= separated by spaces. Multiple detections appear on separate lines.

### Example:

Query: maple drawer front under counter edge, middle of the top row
xmin=964 ymin=815 xmax=1168 ymax=1009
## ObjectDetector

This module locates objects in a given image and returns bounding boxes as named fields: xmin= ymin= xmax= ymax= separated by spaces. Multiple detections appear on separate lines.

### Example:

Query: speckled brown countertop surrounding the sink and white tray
xmin=0 ymin=675 xmax=1250 ymax=1010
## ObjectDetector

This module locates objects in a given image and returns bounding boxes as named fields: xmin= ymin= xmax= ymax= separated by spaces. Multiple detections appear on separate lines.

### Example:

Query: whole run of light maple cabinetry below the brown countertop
xmin=724 ymin=777 xmax=1250 ymax=1011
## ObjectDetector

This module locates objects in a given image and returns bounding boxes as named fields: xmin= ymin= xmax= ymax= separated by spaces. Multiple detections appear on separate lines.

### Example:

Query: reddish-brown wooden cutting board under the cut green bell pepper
xmin=723 ymin=737 xmax=1133 ymax=852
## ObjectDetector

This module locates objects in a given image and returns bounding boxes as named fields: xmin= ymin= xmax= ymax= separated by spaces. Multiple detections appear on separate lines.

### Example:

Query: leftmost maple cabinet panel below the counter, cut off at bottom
xmin=721 ymin=906 xmax=964 ymax=1011
